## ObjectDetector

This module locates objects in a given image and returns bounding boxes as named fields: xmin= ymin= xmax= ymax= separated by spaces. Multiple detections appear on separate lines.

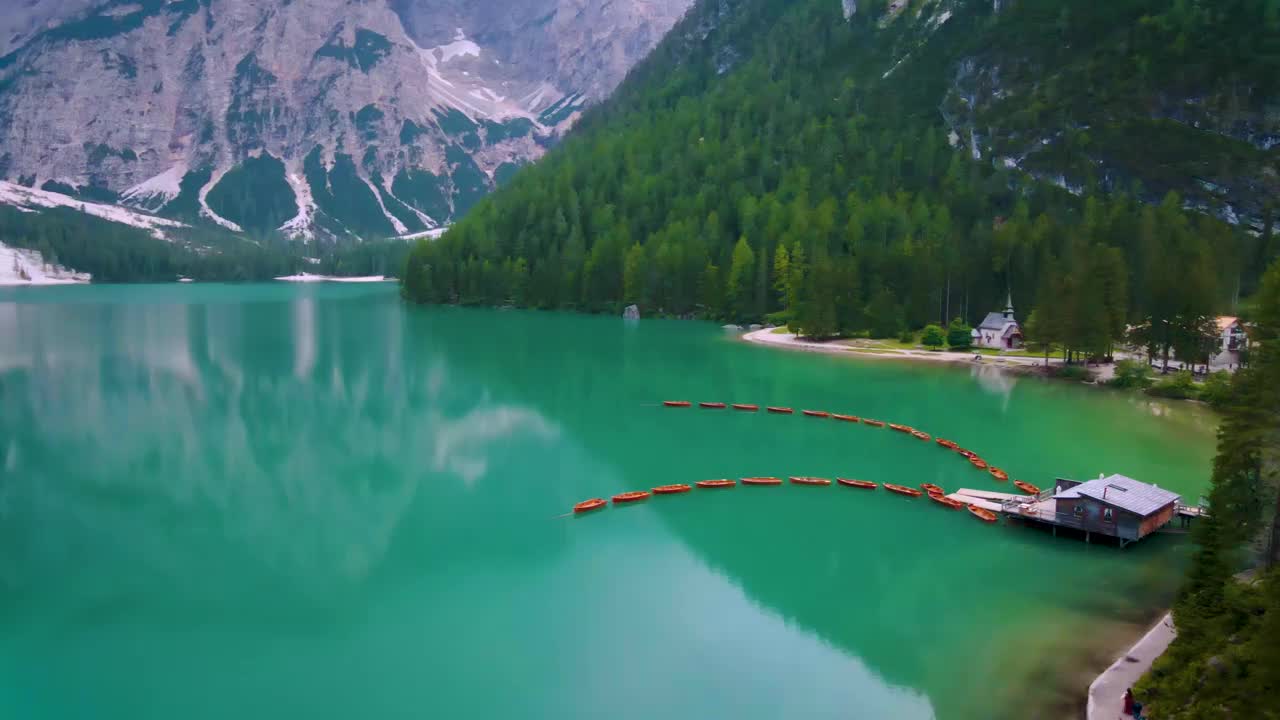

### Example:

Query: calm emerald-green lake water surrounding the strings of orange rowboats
xmin=0 ymin=286 xmax=1213 ymax=720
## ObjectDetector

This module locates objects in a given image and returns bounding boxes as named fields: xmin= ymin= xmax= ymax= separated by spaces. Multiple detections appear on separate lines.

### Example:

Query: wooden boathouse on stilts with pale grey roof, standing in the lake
xmin=1002 ymin=475 xmax=1199 ymax=547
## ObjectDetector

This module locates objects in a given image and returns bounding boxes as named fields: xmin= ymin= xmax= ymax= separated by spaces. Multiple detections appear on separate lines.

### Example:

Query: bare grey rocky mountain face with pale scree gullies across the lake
xmin=0 ymin=0 xmax=690 ymax=240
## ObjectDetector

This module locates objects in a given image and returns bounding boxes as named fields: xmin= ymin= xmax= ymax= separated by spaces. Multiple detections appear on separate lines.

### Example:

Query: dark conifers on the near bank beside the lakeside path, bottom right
xmin=1137 ymin=257 xmax=1280 ymax=720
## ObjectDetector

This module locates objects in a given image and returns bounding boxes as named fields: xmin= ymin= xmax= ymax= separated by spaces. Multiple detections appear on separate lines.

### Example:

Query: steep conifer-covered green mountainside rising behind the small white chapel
xmin=403 ymin=0 xmax=1280 ymax=354
